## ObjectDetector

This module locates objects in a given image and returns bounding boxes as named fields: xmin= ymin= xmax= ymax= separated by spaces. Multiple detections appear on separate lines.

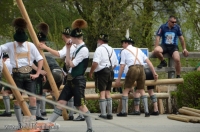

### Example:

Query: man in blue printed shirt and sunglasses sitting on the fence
xmin=153 ymin=16 xmax=188 ymax=78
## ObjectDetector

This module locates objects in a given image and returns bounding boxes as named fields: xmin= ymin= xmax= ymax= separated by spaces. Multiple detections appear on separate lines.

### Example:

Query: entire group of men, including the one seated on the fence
xmin=0 ymin=16 xmax=188 ymax=132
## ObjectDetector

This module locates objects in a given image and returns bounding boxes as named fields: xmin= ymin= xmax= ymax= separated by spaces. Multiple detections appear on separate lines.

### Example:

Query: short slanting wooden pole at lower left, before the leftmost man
xmin=3 ymin=62 xmax=31 ymax=116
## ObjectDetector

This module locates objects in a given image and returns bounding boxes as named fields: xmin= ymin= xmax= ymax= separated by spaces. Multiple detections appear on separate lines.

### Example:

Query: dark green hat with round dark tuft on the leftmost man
xmin=13 ymin=18 xmax=28 ymax=42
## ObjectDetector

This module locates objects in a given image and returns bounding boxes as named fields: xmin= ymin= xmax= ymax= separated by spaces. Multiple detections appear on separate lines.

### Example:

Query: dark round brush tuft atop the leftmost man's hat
xmin=13 ymin=18 xmax=27 ymax=31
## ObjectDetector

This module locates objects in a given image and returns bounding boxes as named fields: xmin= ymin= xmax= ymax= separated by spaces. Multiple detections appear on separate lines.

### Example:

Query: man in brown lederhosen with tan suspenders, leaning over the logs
xmin=116 ymin=37 xmax=158 ymax=117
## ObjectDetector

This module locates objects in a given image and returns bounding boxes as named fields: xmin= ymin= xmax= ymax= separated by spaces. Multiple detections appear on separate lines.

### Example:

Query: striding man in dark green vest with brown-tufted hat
xmin=49 ymin=19 xmax=93 ymax=132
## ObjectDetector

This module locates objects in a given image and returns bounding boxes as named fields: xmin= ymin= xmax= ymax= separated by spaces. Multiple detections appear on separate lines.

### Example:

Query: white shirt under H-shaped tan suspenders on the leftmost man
xmin=0 ymin=41 xmax=43 ymax=68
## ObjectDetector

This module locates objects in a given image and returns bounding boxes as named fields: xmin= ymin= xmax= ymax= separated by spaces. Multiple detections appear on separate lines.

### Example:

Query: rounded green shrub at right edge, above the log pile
xmin=173 ymin=71 xmax=200 ymax=109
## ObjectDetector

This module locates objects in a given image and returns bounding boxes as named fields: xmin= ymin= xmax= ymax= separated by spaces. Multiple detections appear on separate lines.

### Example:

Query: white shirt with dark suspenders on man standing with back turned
xmin=93 ymin=44 xmax=118 ymax=72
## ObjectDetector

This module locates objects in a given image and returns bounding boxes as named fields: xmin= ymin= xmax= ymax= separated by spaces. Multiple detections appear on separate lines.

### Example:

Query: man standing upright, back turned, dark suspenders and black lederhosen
xmin=90 ymin=34 xmax=118 ymax=119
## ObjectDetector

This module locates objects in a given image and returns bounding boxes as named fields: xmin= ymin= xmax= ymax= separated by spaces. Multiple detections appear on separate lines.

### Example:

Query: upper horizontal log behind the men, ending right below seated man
xmin=59 ymin=78 xmax=184 ymax=90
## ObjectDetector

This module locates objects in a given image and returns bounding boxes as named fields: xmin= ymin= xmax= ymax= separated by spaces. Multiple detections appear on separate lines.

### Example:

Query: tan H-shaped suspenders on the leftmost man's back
xmin=13 ymin=42 xmax=30 ymax=68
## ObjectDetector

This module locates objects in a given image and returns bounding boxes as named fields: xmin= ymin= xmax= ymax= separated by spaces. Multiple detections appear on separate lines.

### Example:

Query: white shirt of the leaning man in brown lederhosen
xmin=120 ymin=45 xmax=148 ymax=67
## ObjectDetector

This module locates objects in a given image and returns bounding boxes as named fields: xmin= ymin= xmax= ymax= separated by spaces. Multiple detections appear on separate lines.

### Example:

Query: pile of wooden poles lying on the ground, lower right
xmin=167 ymin=107 xmax=200 ymax=123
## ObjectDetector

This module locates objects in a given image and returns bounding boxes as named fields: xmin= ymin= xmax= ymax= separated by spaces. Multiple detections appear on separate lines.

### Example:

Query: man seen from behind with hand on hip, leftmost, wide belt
xmin=0 ymin=18 xmax=43 ymax=128
